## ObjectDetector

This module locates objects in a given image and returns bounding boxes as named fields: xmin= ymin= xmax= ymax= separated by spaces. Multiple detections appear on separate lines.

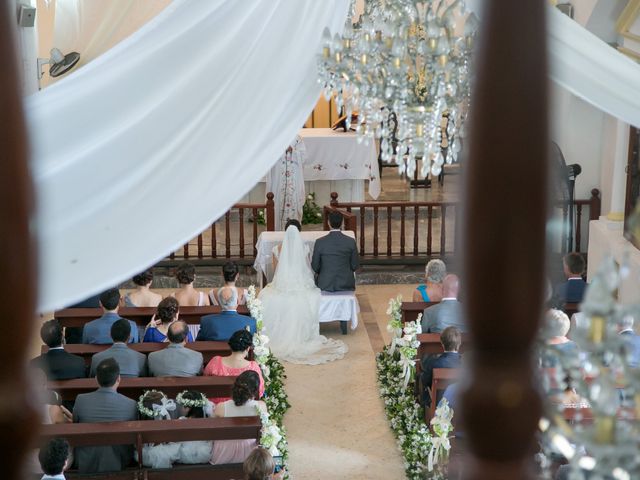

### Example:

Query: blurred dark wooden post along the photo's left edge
xmin=0 ymin=2 xmax=38 ymax=479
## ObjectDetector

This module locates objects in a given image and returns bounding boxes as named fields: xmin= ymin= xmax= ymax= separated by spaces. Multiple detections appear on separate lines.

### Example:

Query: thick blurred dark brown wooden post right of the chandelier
xmin=461 ymin=0 xmax=549 ymax=480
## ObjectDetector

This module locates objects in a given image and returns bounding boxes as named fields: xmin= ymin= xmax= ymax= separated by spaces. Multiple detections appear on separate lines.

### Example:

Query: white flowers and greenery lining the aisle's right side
xmin=376 ymin=295 xmax=451 ymax=480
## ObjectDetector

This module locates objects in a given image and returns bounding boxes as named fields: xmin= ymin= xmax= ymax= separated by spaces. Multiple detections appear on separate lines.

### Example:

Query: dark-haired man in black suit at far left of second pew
xmin=31 ymin=320 xmax=87 ymax=380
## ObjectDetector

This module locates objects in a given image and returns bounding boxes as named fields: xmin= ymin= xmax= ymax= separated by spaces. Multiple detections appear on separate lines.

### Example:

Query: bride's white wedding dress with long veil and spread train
xmin=258 ymin=226 xmax=348 ymax=365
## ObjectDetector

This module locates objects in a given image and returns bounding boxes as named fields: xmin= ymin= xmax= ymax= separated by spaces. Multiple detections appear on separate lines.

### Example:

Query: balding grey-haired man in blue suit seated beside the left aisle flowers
xmin=196 ymin=287 xmax=256 ymax=341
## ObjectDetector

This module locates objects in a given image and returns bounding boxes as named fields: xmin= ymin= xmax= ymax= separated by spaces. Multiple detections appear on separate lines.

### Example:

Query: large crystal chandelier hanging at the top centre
xmin=318 ymin=0 xmax=478 ymax=177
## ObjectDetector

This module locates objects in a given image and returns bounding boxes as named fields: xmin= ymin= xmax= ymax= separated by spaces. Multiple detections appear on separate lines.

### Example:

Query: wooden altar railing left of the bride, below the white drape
xmin=159 ymin=192 xmax=275 ymax=266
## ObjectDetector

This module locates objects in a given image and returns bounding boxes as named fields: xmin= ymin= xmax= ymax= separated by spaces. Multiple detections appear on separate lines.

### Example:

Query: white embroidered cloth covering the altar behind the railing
xmin=299 ymin=128 xmax=380 ymax=199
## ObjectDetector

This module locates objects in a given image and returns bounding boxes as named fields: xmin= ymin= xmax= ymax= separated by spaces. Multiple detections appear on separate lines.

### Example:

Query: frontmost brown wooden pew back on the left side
xmin=53 ymin=305 xmax=249 ymax=327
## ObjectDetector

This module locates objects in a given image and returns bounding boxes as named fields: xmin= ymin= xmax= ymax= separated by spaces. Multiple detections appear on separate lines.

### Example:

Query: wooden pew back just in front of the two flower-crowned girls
xmin=47 ymin=376 xmax=236 ymax=401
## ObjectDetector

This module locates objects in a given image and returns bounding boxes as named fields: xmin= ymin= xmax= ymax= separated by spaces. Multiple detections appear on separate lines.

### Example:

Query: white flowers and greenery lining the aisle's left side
xmin=247 ymin=285 xmax=291 ymax=465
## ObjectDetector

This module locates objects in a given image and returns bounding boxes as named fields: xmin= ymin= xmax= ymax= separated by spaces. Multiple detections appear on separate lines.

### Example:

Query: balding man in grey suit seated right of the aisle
xmin=422 ymin=275 xmax=467 ymax=333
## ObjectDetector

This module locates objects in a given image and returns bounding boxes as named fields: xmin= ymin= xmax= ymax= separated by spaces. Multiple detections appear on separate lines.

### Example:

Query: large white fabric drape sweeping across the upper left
xmin=26 ymin=0 xmax=348 ymax=311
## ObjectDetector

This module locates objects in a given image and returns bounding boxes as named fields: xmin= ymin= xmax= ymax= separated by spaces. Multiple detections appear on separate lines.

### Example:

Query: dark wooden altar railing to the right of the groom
xmin=325 ymin=188 xmax=600 ymax=264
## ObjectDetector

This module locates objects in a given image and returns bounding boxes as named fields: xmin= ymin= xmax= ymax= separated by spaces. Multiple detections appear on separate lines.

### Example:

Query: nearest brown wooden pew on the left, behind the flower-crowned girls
xmin=40 ymin=416 xmax=262 ymax=480
